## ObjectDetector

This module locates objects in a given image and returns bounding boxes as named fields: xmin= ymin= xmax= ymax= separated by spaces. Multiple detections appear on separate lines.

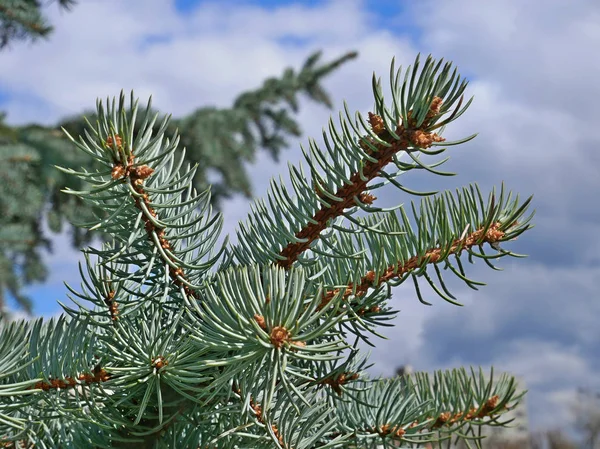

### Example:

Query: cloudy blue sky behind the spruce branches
xmin=0 ymin=0 xmax=600 ymax=438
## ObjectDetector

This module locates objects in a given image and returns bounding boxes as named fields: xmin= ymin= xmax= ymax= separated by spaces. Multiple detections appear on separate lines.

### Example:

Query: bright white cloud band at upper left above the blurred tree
xmin=0 ymin=0 xmax=414 ymax=124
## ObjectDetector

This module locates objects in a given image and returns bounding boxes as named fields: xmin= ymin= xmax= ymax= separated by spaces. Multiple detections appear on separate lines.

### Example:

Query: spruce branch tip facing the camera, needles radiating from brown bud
xmin=184 ymin=266 xmax=348 ymax=410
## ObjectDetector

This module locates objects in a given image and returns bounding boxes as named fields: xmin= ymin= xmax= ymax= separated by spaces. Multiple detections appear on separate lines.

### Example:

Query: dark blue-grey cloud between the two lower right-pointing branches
xmin=423 ymin=261 xmax=600 ymax=363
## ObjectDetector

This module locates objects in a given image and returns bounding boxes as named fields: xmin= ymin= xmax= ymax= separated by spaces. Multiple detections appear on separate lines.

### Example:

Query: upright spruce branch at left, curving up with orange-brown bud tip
xmin=61 ymin=93 xmax=226 ymax=319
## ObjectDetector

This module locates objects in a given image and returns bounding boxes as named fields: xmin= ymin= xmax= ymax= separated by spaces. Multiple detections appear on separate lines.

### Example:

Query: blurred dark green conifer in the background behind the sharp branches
xmin=0 ymin=45 xmax=357 ymax=315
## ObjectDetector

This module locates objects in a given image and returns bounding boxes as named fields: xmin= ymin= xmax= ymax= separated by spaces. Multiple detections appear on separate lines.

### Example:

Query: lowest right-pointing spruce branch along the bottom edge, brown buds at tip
xmin=337 ymin=368 xmax=523 ymax=447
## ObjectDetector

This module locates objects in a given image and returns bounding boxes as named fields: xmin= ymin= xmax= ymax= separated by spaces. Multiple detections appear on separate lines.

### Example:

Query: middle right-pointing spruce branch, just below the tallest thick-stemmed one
xmin=300 ymin=186 xmax=532 ymax=344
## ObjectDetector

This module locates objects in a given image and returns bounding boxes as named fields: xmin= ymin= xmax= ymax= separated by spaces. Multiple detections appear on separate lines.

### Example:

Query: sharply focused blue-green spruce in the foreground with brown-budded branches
xmin=0 ymin=53 xmax=532 ymax=449
